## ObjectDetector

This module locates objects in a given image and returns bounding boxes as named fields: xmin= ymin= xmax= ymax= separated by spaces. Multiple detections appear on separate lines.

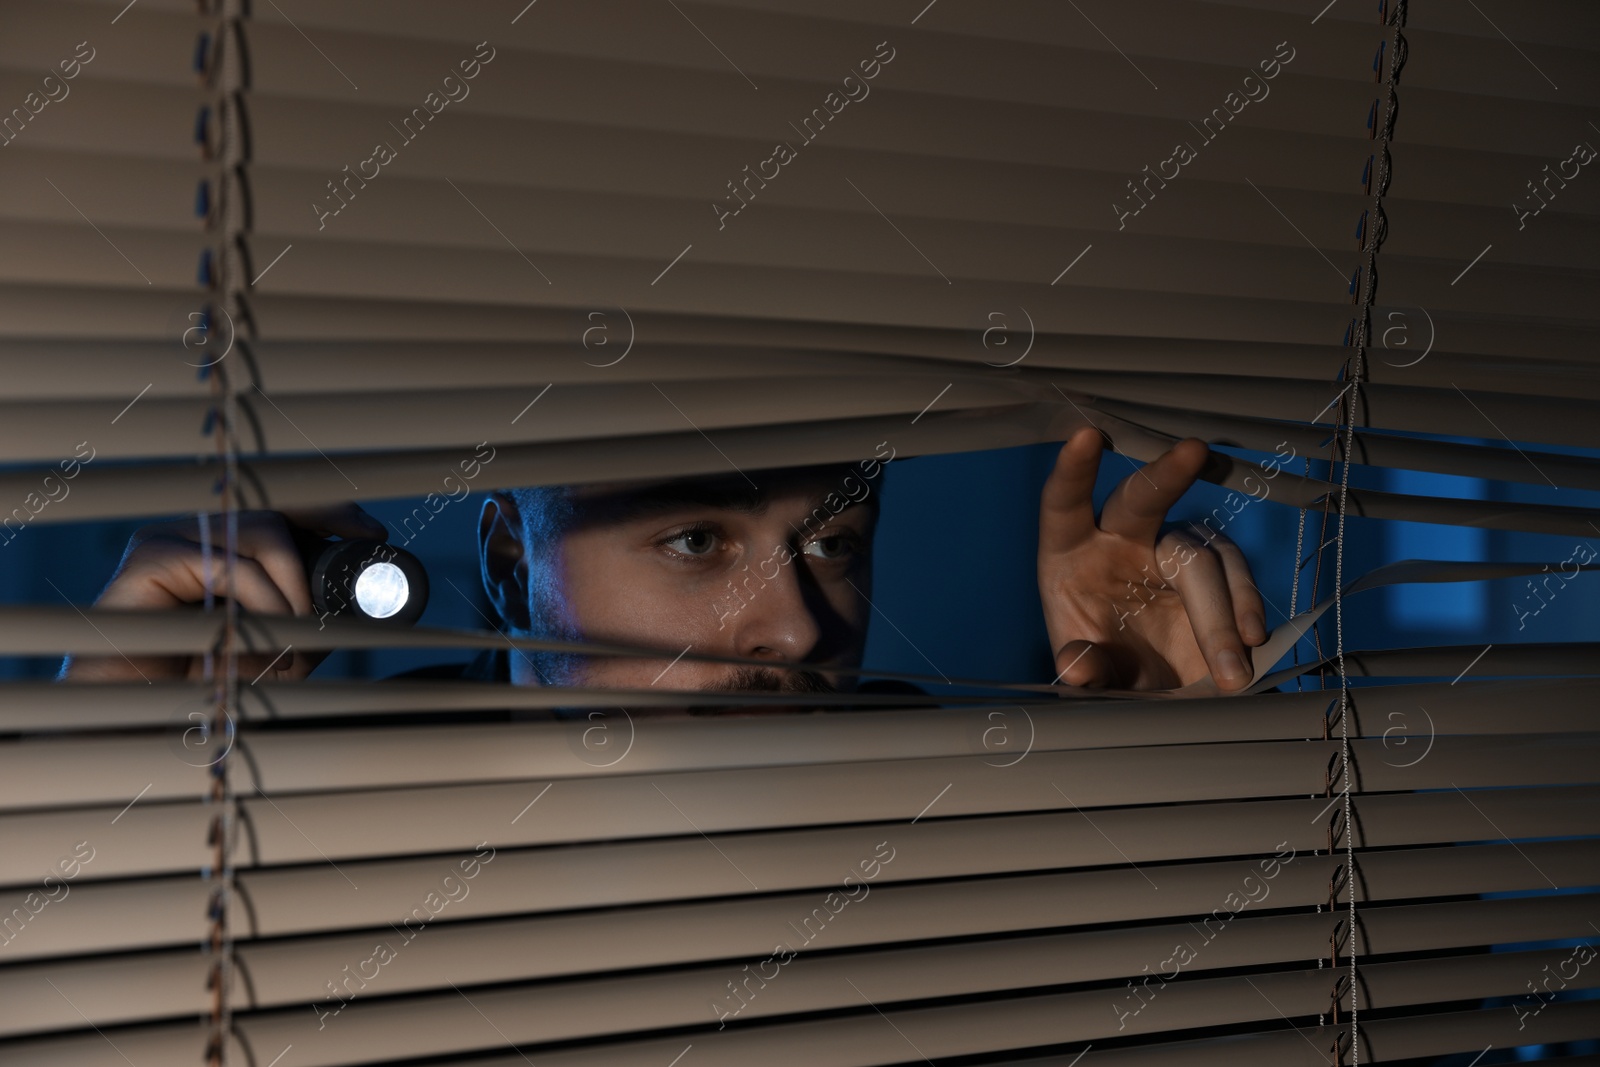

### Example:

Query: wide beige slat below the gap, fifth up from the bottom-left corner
xmin=0 ymin=686 xmax=1600 ymax=809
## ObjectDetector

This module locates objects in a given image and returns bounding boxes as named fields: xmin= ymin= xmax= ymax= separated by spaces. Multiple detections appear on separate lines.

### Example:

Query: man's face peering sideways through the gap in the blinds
xmin=485 ymin=467 xmax=877 ymax=691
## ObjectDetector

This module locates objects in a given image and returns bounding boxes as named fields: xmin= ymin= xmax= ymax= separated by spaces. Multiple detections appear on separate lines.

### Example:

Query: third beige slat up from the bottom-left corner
xmin=6 ymin=831 xmax=1600 ymax=961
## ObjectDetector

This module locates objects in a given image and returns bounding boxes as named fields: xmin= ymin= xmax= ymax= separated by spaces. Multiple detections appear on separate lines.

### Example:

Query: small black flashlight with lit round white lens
xmin=296 ymin=536 xmax=427 ymax=625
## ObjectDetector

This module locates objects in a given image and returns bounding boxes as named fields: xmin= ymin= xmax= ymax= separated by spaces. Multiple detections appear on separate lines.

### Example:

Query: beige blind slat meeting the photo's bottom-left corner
xmin=6 ymin=950 xmax=1594 ymax=1067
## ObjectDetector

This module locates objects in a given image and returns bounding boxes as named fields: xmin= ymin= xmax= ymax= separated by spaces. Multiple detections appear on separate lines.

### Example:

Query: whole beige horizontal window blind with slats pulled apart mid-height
xmin=0 ymin=0 xmax=1600 ymax=1067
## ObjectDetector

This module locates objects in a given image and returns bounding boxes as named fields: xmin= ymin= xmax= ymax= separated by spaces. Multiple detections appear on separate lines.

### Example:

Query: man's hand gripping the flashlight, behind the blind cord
xmin=61 ymin=504 xmax=389 ymax=681
